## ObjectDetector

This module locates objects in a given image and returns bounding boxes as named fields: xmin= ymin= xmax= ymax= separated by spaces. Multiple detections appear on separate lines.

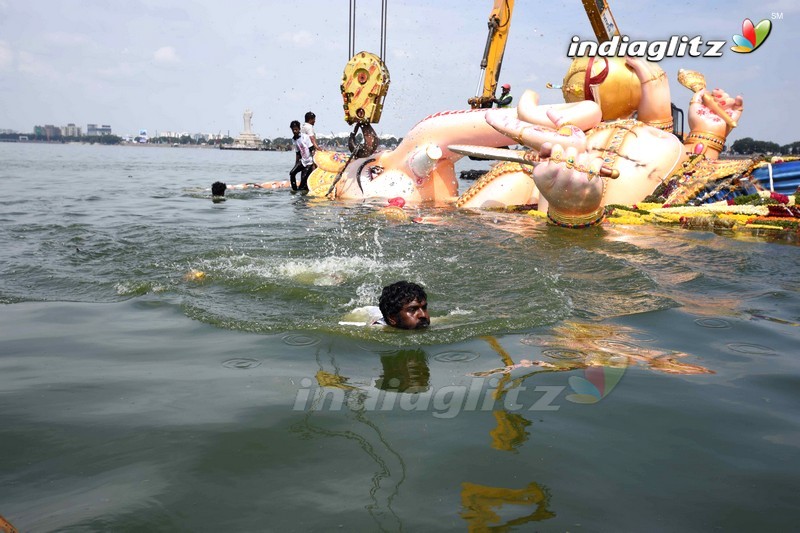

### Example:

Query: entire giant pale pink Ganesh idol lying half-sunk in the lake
xmin=309 ymin=58 xmax=742 ymax=226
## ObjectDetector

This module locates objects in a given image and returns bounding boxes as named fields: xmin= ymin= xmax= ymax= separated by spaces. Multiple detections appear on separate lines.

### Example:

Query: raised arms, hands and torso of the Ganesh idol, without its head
xmin=476 ymin=58 xmax=742 ymax=227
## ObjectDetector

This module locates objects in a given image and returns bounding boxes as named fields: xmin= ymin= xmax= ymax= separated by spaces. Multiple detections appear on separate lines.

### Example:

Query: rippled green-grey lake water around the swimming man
xmin=0 ymin=144 xmax=800 ymax=532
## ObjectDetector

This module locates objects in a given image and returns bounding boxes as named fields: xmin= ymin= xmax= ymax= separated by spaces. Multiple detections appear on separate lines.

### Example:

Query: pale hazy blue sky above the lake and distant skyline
xmin=0 ymin=0 xmax=800 ymax=144
